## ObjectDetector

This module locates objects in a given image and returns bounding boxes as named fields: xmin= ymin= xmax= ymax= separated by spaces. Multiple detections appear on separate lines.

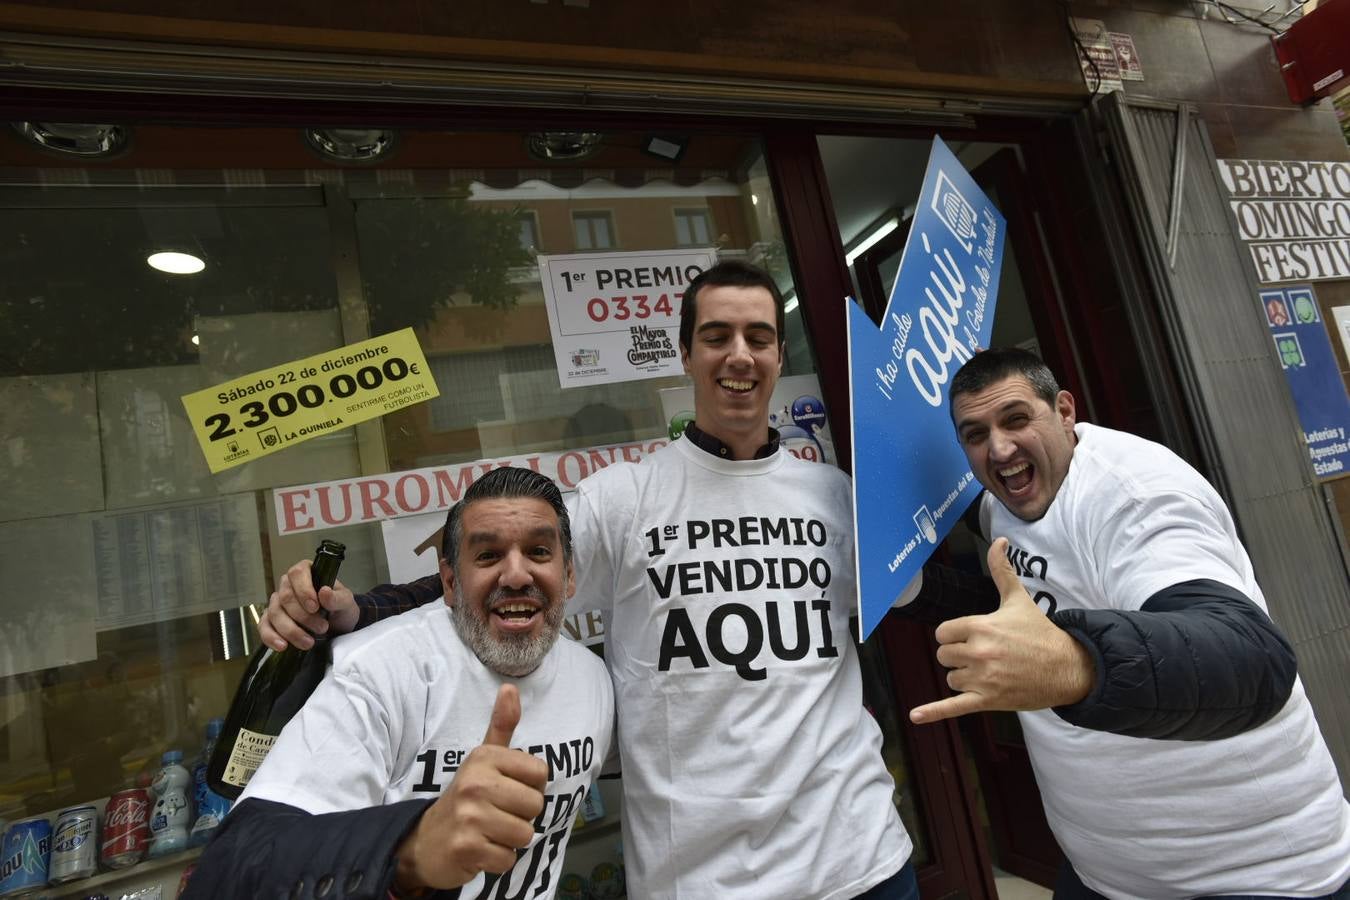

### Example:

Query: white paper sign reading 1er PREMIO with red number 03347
xmin=539 ymin=248 xmax=717 ymax=387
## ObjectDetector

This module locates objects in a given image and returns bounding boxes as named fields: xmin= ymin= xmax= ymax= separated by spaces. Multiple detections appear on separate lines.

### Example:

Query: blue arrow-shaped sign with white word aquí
xmin=845 ymin=138 xmax=1007 ymax=640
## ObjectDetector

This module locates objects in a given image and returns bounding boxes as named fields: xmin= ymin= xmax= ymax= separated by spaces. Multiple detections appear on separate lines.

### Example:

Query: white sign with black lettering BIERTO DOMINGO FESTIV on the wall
xmin=1219 ymin=159 xmax=1350 ymax=285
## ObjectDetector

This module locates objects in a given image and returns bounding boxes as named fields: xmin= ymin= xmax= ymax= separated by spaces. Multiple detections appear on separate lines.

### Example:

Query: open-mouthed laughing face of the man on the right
xmin=952 ymin=375 xmax=1076 ymax=522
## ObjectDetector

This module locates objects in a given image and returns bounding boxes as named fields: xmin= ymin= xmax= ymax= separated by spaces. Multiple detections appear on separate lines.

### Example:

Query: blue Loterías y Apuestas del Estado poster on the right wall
xmin=1261 ymin=285 xmax=1350 ymax=478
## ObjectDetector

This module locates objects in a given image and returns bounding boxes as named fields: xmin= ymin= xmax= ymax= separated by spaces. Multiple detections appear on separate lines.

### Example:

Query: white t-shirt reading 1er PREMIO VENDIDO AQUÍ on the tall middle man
xmin=572 ymin=439 xmax=911 ymax=900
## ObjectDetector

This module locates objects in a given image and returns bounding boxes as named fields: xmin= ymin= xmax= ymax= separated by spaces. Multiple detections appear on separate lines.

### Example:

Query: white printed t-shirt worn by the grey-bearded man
xmin=240 ymin=603 xmax=614 ymax=900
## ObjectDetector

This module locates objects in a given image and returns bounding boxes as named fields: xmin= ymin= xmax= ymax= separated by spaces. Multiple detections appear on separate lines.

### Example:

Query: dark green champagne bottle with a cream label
xmin=207 ymin=541 xmax=347 ymax=800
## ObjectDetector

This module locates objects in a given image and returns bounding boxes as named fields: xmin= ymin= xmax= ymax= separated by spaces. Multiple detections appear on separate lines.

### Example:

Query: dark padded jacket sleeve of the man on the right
xmin=1050 ymin=579 xmax=1296 ymax=741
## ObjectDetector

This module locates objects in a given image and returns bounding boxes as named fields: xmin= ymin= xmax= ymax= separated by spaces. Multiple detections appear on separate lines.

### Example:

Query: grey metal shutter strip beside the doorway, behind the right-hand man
xmin=1096 ymin=93 xmax=1350 ymax=785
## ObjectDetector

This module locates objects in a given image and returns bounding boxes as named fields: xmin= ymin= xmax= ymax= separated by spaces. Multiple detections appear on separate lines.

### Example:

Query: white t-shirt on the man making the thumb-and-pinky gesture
xmin=981 ymin=424 xmax=1350 ymax=900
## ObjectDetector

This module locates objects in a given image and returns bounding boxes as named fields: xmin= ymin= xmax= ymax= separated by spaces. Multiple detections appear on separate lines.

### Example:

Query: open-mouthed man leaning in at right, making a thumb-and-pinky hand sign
xmin=911 ymin=348 xmax=1350 ymax=900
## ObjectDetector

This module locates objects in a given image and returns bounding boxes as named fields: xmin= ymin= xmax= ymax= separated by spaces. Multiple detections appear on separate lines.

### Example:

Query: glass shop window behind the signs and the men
xmin=0 ymin=125 xmax=814 ymax=874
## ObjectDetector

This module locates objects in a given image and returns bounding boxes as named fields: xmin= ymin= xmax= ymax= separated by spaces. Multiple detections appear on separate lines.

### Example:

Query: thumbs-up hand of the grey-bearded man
xmin=396 ymin=684 xmax=548 ymax=891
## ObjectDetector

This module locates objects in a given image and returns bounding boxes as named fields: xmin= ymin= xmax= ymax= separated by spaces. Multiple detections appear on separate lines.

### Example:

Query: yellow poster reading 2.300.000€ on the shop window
xmin=182 ymin=328 xmax=440 ymax=472
